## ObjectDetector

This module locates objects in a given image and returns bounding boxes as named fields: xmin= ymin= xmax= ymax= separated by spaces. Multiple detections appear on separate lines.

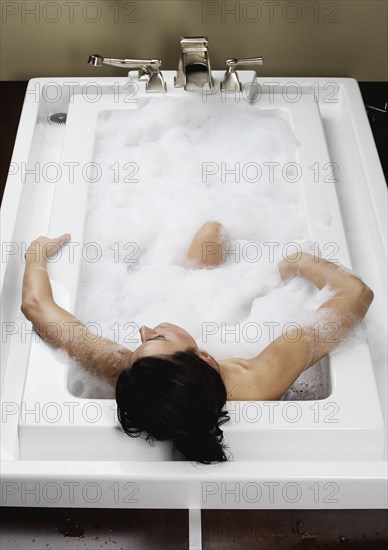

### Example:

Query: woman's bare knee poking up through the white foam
xmin=184 ymin=222 xmax=226 ymax=269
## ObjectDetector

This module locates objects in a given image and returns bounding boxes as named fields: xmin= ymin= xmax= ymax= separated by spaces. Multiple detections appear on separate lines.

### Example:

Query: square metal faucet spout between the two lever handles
xmin=174 ymin=36 xmax=214 ymax=90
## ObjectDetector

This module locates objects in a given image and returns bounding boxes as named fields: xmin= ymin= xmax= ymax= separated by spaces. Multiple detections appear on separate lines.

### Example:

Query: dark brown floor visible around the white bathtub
xmin=0 ymin=82 xmax=388 ymax=550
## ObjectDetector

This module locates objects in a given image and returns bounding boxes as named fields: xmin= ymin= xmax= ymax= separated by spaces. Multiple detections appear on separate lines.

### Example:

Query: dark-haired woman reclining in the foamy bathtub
xmin=21 ymin=222 xmax=373 ymax=464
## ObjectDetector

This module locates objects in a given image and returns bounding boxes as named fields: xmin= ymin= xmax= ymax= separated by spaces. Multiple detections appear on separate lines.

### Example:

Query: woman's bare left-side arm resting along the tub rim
xmin=21 ymin=235 xmax=132 ymax=386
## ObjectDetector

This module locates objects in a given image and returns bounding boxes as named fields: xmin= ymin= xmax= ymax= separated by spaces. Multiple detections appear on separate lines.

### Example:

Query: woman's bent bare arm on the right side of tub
xmin=247 ymin=253 xmax=373 ymax=399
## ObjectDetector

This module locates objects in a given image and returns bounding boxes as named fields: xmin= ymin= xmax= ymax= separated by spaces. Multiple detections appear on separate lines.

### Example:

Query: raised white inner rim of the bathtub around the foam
xmin=19 ymin=75 xmax=384 ymax=466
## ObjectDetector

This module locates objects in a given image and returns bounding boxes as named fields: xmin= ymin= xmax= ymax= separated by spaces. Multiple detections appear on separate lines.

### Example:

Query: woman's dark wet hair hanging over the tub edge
xmin=116 ymin=348 xmax=230 ymax=464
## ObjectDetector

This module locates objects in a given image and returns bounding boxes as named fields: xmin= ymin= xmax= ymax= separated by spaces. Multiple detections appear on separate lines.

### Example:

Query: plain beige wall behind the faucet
xmin=0 ymin=0 xmax=388 ymax=81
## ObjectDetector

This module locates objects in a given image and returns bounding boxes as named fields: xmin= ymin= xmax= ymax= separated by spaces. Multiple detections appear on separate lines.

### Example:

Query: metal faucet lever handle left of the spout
xmin=88 ymin=54 xmax=167 ymax=93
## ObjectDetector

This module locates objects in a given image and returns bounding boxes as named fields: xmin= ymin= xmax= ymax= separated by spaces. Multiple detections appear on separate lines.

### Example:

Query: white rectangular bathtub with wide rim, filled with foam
xmin=1 ymin=71 xmax=387 ymax=510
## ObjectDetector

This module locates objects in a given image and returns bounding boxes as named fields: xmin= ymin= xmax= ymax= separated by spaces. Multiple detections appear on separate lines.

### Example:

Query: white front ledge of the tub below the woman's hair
xmin=2 ymin=461 xmax=388 ymax=510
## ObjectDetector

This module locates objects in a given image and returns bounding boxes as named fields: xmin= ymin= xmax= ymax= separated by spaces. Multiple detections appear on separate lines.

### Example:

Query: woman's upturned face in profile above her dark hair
xmin=130 ymin=323 xmax=197 ymax=365
